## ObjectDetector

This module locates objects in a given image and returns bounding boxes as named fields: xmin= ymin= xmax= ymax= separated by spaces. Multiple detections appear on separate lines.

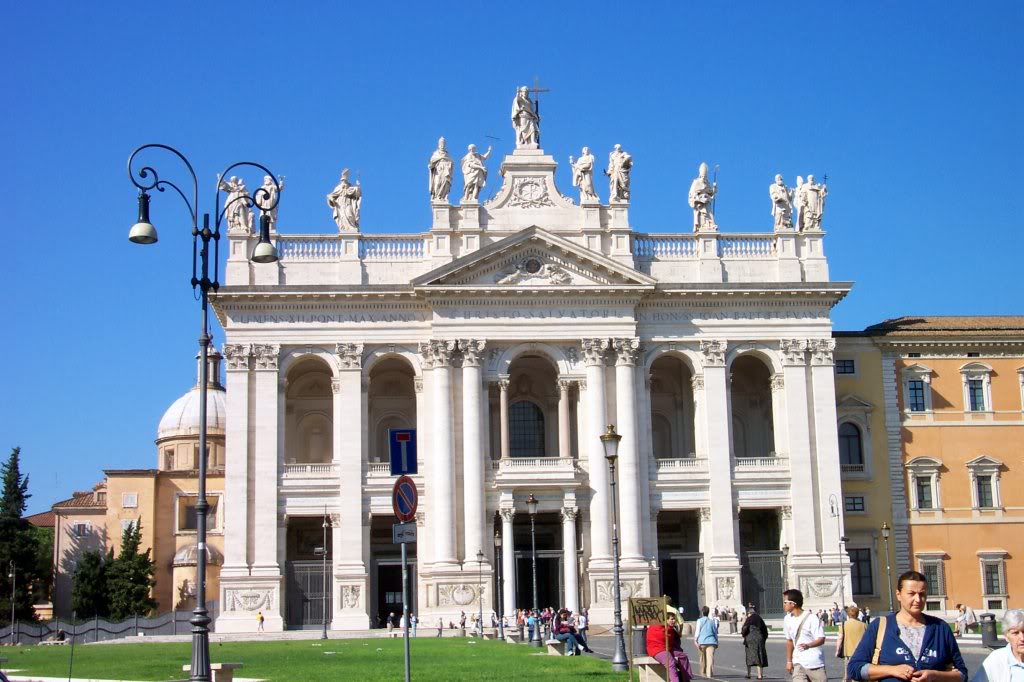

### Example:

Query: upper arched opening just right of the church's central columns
xmin=650 ymin=355 xmax=696 ymax=459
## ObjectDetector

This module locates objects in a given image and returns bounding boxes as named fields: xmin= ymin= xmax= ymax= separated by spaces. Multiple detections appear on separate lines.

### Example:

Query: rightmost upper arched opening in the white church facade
xmin=729 ymin=355 xmax=775 ymax=458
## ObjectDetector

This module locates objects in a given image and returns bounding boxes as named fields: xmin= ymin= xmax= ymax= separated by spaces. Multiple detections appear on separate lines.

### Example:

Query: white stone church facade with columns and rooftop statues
xmin=214 ymin=92 xmax=850 ymax=633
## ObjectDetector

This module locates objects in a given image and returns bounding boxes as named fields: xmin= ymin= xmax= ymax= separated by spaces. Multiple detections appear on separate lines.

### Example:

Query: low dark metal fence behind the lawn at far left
xmin=0 ymin=601 xmax=218 ymax=644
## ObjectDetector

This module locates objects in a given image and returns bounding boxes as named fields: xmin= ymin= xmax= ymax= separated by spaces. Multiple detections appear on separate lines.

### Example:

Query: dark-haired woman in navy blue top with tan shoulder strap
xmin=847 ymin=570 xmax=967 ymax=682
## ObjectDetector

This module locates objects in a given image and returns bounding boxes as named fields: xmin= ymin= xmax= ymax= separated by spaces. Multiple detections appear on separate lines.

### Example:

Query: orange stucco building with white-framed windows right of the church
xmin=865 ymin=316 xmax=1024 ymax=614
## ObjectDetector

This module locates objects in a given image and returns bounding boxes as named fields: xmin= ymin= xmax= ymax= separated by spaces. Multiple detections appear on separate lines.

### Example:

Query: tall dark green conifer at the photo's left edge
xmin=0 ymin=447 xmax=39 ymax=624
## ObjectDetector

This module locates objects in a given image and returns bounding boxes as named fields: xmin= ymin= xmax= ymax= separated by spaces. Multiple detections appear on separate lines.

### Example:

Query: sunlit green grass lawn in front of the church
xmin=0 ymin=638 xmax=628 ymax=682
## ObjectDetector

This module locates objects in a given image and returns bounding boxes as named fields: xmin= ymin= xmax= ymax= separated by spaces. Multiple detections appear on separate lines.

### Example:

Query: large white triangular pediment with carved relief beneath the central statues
xmin=412 ymin=226 xmax=655 ymax=289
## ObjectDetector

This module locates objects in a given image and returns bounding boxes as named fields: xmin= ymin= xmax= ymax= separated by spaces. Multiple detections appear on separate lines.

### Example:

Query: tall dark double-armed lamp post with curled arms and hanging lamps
xmin=128 ymin=144 xmax=281 ymax=682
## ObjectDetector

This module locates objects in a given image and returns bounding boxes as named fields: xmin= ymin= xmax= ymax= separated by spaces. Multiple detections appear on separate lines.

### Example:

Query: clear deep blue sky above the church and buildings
xmin=0 ymin=2 xmax=1024 ymax=512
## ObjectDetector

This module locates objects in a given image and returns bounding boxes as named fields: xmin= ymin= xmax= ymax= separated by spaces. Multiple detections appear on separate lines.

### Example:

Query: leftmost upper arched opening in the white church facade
xmin=285 ymin=357 xmax=334 ymax=464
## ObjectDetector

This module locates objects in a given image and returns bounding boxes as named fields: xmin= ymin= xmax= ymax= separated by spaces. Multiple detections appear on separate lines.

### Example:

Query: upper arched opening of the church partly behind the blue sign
xmin=367 ymin=357 xmax=416 ymax=462
